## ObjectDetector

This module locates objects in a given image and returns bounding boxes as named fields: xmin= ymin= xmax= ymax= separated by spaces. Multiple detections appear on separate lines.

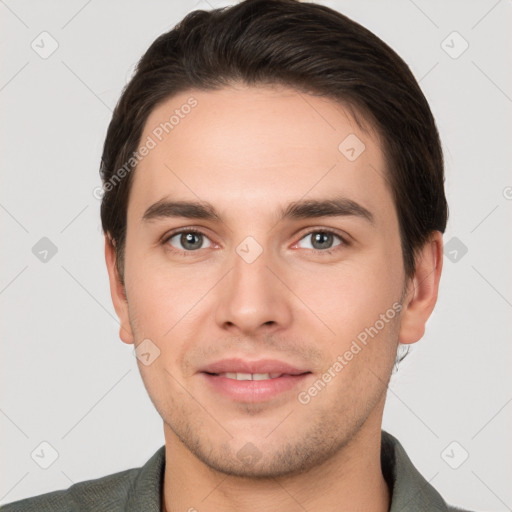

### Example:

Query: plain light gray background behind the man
xmin=0 ymin=0 xmax=512 ymax=511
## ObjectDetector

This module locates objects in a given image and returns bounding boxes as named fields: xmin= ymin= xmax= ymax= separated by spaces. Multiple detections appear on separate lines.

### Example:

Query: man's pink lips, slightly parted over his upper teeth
xmin=200 ymin=359 xmax=311 ymax=403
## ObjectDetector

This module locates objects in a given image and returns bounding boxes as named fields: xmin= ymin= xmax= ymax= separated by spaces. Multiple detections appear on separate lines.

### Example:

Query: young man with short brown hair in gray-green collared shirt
xmin=3 ymin=0 xmax=472 ymax=512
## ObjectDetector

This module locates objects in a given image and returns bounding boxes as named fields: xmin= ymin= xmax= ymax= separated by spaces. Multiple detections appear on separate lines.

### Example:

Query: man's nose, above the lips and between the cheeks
xmin=215 ymin=241 xmax=292 ymax=336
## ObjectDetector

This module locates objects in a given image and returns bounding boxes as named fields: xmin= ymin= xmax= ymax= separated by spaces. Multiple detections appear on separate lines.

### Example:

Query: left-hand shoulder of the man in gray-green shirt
xmin=0 ymin=447 xmax=165 ymax=512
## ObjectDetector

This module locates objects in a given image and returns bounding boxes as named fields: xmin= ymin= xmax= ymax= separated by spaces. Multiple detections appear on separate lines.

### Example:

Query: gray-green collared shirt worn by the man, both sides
xmin=0 ymin=432 xmax=472 ymax=512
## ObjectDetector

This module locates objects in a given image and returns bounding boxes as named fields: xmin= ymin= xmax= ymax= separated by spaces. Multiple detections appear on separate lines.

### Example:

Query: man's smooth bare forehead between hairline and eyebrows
xmin=129 ymin=86 xmax=390 ymax=222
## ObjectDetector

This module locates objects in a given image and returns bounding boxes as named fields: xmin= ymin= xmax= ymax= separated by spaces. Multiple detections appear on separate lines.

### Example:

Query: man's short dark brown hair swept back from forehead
xmin=100 ymin=0 xmax=448 ymax=279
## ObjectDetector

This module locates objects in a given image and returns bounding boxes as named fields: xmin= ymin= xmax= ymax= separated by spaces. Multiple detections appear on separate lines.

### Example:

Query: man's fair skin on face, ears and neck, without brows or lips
xmin=105 ymin=85 xmax=443 ymax=512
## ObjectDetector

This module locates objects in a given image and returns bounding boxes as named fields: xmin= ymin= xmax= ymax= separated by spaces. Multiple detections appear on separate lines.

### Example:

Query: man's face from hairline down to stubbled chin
xmin=109 ymin=86 xmax=432 ymax=476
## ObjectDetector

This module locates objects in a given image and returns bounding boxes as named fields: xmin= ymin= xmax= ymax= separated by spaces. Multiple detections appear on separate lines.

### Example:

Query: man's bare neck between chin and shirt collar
xmin=162 ymin=423 xmax=391 ymax=512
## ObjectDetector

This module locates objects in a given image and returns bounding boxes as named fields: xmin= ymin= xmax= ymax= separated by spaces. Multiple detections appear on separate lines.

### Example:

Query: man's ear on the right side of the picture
xmin=398 ymin=231 xmax=443 ymax=344
